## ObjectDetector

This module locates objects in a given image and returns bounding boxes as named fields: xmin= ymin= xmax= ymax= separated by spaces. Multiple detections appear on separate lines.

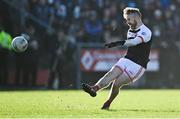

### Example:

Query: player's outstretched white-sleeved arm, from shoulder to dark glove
xmin=124 ymin=32 xmax=151 ymax=47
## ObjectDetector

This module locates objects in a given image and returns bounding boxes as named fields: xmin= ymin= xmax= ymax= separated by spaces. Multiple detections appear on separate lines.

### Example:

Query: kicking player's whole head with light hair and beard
xmin=123 ymin=7 xmax=141 ymax=28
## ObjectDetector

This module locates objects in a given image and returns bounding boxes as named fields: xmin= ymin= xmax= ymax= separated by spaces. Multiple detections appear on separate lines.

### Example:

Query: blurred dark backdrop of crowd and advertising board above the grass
xmin=0 ymin=0 xmax=180 ymax=90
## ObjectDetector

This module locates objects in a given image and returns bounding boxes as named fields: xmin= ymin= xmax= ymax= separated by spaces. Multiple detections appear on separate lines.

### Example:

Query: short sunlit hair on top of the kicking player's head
xmin=123 ymin=7 xmax=141 ymax=18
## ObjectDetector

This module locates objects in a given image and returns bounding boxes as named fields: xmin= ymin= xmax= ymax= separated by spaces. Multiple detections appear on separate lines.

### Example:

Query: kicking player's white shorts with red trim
xmin=114 ymin=58 xmax=145 ymax=82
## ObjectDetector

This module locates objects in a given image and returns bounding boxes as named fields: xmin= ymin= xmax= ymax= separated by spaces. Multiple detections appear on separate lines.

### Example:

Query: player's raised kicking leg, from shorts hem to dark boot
xmin=82 ymin=66 xmax=123 ymax=97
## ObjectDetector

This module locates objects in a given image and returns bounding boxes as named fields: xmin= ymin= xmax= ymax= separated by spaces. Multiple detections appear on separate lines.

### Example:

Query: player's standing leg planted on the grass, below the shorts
xmin=101 ymin=73 xmax=131 ymax=109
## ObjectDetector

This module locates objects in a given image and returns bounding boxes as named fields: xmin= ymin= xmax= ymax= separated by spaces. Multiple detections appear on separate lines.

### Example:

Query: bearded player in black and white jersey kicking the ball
xmin=82 ymin=7 xmax=152 ymax=109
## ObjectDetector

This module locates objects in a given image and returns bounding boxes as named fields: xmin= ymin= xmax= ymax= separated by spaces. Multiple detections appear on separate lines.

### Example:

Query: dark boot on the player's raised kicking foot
xmin=81 ymin=83 xmax=96 ymax=97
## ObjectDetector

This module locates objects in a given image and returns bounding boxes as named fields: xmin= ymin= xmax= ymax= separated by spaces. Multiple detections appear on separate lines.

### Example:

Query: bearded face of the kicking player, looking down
xmin=126 ymin=15 xmax=137 ymax=29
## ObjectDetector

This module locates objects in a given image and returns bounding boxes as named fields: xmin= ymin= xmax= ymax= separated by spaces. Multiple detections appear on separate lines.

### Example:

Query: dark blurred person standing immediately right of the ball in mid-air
xmin=23 ymin=24 xmax=39 ymax=87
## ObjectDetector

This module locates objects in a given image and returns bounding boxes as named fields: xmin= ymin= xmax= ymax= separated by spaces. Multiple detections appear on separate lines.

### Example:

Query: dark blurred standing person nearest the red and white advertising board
xmin=48 ymin=30 xmax=67 ymax=89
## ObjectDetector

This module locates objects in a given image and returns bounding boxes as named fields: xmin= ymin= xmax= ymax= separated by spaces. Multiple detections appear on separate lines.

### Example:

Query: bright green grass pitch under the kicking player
xmin=0 ymin=90 xmax=180 ymax=118
